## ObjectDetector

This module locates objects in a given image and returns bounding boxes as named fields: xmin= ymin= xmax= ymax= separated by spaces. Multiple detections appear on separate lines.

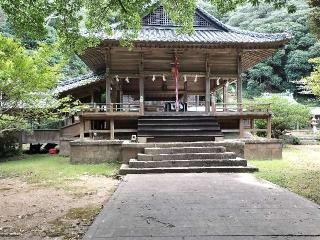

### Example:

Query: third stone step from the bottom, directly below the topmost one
xmin=138 ymin=152 xmax=236 ymax=161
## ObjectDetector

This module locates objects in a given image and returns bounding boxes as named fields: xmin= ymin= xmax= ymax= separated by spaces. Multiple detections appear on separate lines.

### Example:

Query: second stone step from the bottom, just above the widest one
xmin=129 ymin=158 xmax=247 ymax=168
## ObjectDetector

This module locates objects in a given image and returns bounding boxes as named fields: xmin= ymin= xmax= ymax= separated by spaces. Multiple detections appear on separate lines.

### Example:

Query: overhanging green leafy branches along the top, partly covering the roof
xmin=0 ymin=0 xmax=295 ymax=52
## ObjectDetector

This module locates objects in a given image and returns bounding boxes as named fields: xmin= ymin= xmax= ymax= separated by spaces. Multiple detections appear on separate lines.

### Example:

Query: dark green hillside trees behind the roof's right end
xmin=225 ymin=1 xmax=320 ymax=97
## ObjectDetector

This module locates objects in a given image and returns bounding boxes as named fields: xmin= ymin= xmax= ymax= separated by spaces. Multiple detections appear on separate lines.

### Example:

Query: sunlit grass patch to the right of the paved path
xmin=250 ymin=145 xmax=320 ymax=204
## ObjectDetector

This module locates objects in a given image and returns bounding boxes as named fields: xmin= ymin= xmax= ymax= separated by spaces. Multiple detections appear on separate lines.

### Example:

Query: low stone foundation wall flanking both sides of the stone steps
xmin=65 ymin=139 xmax=282 ymax=164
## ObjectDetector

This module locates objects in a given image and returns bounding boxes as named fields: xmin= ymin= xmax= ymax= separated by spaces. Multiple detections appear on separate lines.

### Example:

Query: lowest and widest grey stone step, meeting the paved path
xmin=119 ymin=164 xmax=258 ymax=175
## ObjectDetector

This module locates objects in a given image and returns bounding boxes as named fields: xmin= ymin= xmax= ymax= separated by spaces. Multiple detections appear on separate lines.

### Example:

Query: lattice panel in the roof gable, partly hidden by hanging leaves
xmin=142 ymin=6 xmax=212 ymax=27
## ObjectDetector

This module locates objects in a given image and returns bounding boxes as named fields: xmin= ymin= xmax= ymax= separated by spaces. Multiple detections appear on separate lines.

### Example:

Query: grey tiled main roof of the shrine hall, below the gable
xmin=90 ymin=7 xmax=291 ymax=44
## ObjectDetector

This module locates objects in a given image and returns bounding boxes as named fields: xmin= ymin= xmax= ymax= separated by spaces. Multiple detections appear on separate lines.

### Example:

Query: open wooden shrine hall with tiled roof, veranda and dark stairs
xmin=57 ymin=7 xmax=289 ymax=142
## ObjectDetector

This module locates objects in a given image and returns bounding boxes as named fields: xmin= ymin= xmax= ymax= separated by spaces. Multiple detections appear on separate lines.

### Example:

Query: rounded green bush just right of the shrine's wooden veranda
xmin=253 ymin=95 xmax=311 ymax=138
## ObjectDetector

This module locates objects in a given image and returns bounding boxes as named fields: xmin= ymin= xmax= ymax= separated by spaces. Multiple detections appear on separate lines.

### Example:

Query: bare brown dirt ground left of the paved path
xmin=0 ymin=175 xmax=119 ymax=240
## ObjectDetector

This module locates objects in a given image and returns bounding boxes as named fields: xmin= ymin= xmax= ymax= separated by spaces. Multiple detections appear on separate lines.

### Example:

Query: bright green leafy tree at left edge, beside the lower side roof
xmin=0 ymin=35 xmax=84 ymax=141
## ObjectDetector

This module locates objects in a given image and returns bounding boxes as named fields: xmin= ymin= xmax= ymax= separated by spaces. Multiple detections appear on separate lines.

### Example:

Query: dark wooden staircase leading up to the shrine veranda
xmin=138 ymin=113 xmax=223 ymax=142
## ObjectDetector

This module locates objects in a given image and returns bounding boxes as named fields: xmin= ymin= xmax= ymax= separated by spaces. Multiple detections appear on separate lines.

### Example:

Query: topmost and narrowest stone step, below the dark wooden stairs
xmin=144 ymin=146 xmax=226 ymax=154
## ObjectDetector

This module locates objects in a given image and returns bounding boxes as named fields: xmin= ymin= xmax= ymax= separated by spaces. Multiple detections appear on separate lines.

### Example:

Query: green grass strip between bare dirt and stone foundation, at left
xmin=0 ymin=155 xmax=120 ymax=184
